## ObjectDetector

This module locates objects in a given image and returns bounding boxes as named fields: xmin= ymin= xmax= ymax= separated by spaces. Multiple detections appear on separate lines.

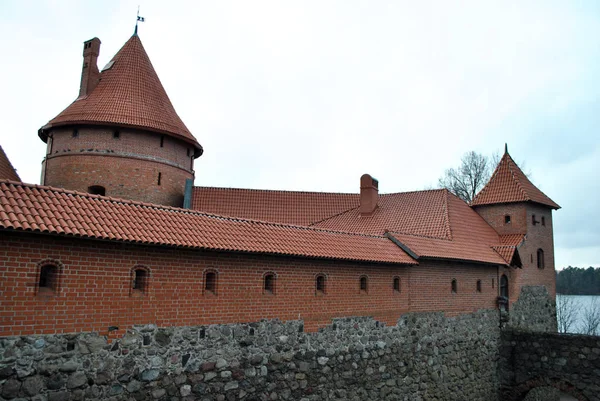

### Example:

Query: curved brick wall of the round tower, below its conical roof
xmin=42 ymin=127 xmax=194 ymax=207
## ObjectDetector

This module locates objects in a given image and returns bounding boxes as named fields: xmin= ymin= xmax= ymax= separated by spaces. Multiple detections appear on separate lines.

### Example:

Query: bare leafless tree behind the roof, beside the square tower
xmin=438 ymin=151 xmax=495 ymax=202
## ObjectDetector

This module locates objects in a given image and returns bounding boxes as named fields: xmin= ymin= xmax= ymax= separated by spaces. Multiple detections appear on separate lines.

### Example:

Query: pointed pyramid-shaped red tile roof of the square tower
xmin=471 ymin=152 xmax=560 ymax=209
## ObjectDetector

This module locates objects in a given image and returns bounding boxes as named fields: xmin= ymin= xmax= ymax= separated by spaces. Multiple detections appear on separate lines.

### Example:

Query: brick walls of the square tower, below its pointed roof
xmin=475 ymin=203 xmax=556 ymax=304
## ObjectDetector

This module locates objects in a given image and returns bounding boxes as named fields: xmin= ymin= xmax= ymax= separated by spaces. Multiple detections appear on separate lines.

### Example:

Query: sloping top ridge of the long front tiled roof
xmin=0 ymin=179 xmax=385 ymax=238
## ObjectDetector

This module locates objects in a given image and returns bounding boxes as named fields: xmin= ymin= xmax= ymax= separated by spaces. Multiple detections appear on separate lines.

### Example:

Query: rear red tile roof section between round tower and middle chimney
xmin=192 ymin=187 xmax=359 ymax=225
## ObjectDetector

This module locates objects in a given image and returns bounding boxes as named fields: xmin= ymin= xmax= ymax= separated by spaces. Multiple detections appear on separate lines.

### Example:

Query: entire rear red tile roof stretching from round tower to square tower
xmin=193 ymin=188 xmax=508 ymax=265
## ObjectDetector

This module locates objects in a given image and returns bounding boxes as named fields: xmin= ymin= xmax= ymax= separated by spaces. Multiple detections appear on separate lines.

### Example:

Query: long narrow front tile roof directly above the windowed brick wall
xmin=0 ymin=181 xmax=416 ymax=265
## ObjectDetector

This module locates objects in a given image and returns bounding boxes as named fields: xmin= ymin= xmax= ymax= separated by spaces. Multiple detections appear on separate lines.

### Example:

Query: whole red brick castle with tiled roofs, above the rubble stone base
xmin=0 ymin=34 xmax=559 ymax=336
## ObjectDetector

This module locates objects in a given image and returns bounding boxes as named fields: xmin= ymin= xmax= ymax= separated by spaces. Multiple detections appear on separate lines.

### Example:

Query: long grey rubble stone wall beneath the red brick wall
xmin=0 ymin=311 xmax=500 ymax=401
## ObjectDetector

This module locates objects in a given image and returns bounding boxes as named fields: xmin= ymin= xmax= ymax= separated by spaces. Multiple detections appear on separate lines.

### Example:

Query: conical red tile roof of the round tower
xmin=40 ymin=35 xmax=202 ymax=152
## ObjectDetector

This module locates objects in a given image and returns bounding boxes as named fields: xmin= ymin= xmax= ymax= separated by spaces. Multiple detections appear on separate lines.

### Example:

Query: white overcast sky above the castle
xmin=0 ymin=0 xmax=600 ymax=268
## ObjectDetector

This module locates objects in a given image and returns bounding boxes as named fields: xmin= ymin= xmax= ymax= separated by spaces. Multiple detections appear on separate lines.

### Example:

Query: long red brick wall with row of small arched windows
xmin=0 ymin=232 xmax=497 ymax=336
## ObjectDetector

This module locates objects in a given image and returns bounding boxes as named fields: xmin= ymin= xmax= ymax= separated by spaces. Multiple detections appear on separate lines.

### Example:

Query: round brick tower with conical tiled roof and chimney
xmin=38 ymin=34 xmax=202 ymax=207
